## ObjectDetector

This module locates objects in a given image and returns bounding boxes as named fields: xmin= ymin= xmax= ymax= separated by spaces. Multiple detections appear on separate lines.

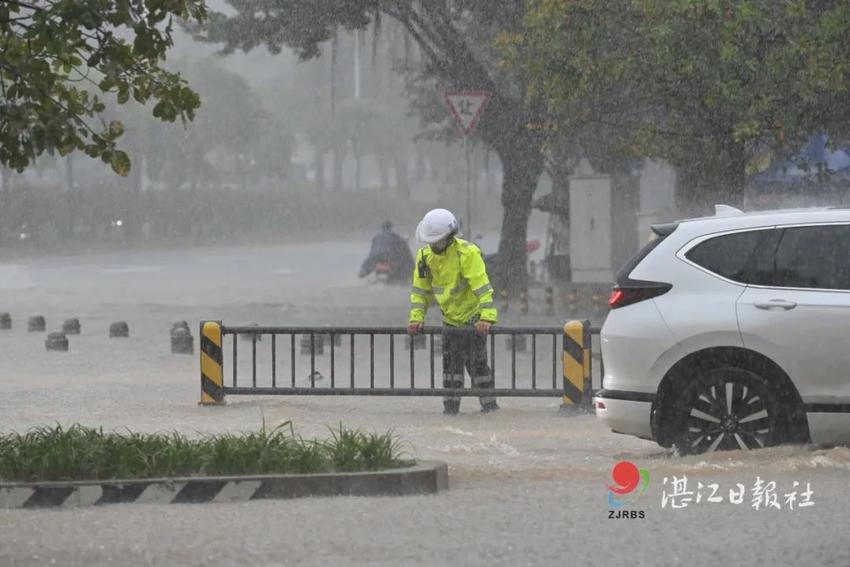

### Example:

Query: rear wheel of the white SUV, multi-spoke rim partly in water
xmin=673 ymin=367 xmax=780 ymax=454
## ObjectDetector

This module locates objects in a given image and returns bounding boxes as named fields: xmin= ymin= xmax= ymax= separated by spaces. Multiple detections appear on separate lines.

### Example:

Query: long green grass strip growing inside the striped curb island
xmin=0 ymin=422 xmax=410 ymax=482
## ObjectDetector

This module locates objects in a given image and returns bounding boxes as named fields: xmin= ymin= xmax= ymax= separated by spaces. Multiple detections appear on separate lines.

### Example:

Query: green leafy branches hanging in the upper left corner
xmin=0 ymin=0 xmax=205 ymax=175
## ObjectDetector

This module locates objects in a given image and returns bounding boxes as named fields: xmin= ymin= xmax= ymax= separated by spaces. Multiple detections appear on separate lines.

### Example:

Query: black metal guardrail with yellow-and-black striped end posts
xmin=201 ymin=321 xmax=598 ymax=405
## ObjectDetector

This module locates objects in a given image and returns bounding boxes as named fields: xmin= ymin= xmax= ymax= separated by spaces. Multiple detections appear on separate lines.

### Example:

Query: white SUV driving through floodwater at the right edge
xmin=594 ymin=206 xmax=850 ymax=453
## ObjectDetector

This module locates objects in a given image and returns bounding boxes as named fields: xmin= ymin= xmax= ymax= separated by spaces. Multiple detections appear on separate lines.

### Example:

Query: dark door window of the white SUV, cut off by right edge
xmin=768 ymin=225 xmax=850 ymax=290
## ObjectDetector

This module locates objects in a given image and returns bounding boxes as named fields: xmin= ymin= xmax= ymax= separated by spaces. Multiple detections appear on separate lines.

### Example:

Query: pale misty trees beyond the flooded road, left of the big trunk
xmin=0 ymin=11 xmax=524 ymax=255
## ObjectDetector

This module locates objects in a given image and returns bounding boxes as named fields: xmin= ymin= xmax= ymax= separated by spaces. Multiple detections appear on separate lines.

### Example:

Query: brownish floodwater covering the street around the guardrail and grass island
xmin=0 ymin=242 xmax=850 ymax=566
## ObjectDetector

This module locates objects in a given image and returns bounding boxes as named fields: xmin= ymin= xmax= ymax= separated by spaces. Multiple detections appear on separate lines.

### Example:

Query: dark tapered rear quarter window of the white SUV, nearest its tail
xmin=685 ymin=229 xmax=782 ymax=285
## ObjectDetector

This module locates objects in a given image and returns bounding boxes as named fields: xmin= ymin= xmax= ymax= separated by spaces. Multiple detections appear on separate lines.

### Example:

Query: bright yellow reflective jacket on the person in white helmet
xmin=410 ymin=238 xmax=498 ymax=327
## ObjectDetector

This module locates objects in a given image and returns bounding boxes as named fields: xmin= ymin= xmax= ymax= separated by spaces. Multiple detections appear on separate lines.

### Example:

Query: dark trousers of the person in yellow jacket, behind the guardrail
xmin=443 ymin=325 xmax=496 ymax=411
